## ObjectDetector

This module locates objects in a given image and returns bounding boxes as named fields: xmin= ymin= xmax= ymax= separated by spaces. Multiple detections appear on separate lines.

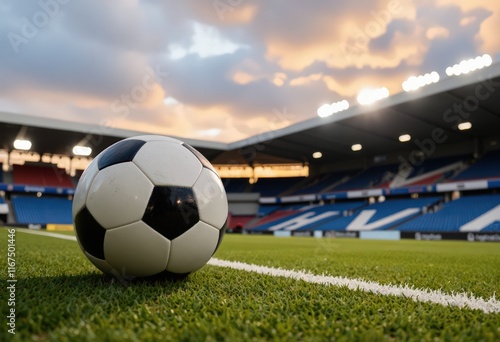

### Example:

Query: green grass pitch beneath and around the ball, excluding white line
xmin=0 ymin=229 xmax=500 ymax=341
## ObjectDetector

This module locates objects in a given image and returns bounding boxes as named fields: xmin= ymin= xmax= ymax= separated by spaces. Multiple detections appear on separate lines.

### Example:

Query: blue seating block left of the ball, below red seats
xmin=12 ymin=196 xmax=72 ymax=225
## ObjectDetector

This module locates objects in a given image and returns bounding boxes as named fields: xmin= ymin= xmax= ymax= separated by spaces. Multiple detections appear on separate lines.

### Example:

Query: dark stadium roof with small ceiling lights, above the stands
xmin=0 ymin=63 xmax=500 ymax=164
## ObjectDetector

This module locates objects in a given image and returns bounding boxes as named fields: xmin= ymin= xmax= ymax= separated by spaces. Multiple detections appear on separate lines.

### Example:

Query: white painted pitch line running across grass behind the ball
xmin=16 ymin=229 xmax=500 ymax=314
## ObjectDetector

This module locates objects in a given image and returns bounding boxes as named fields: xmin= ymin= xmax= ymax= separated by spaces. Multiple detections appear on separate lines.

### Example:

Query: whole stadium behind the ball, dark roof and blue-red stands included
xmin=0 ymin=63 xmax=500 ymax=240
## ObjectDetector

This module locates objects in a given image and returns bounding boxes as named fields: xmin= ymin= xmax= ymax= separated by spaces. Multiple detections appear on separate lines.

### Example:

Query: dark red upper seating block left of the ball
xmin=12 ymin=165 xmax=74 ymax=188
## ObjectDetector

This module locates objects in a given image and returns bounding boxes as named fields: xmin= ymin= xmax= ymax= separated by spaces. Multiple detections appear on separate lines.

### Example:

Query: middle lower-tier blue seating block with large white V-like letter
xmin=309 ymin=197 xmax=441 ymax=231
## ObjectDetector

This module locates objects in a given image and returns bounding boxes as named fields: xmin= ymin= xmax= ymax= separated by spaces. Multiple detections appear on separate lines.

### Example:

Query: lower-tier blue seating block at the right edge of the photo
xmin=397 ymin=194 xmax=500 ymax=232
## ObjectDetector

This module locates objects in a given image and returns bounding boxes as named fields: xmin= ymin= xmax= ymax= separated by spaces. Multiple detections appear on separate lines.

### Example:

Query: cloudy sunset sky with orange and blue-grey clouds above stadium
xmin=0 ymin=0 xmax=500 ymax=142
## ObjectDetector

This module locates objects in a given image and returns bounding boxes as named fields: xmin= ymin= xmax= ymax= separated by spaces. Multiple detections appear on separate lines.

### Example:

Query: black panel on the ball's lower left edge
xmin=75 ymin=207 xmax=106 ymax=260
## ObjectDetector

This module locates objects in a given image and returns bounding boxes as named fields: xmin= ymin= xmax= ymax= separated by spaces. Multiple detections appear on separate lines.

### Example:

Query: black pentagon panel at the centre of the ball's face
xmin=142 ymin=186 xmax=200 ymax=240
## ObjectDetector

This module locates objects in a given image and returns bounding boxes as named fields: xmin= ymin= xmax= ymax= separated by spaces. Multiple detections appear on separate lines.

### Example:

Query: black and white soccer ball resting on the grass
xmin=72 ymin=135 xmax=228 ymax=279
